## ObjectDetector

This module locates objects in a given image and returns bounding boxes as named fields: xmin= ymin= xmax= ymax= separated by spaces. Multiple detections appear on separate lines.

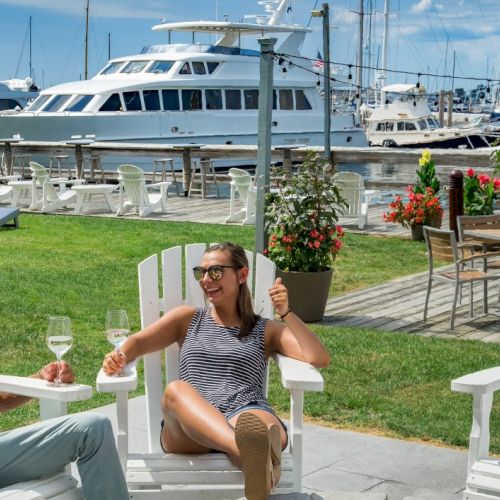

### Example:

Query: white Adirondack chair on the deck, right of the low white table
xmin=116 ymin=165 xmax=171 ymax=217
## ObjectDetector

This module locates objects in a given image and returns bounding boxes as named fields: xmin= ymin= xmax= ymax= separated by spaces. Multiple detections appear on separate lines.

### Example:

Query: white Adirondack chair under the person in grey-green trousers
xmin=0 ymin=375 xmax=92 ymax=500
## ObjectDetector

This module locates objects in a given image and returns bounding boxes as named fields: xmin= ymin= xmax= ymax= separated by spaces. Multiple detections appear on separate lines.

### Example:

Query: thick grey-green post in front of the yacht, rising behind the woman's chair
xmin=255 ymin=38 xmax=277 ymax=253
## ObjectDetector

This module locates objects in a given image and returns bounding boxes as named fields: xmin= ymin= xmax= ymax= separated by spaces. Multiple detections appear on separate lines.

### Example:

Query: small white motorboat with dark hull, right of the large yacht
xmin=365 ymin=84 xmax=494 ymax=148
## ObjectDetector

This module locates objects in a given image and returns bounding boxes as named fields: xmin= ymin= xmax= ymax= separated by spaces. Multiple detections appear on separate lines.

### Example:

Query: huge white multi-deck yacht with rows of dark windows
xmin=0 ymin=0 xmax=367 ymax=146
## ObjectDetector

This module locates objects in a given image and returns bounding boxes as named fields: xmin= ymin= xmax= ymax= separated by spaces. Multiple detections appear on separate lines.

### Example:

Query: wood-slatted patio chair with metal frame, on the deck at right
xmin=424 ymin=226 xmax=500 ymax=330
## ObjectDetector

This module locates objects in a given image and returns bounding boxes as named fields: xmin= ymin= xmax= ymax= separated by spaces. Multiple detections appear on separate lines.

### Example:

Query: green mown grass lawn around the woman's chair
xmin=0 ymin=214 xmax=500 ymax=451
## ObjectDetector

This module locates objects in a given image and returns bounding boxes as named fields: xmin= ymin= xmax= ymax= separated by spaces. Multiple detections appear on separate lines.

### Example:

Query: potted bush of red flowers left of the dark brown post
xmin=384 ymin=185 xmax=443 ymax=241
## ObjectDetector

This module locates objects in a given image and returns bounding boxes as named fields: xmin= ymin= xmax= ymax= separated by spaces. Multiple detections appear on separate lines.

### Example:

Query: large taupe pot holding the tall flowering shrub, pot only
xmin=276 ymin=269 xmax=333 ymax=322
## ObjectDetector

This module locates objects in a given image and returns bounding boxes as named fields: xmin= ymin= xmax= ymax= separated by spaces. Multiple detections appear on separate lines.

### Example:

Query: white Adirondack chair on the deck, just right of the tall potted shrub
xmin=335 ymin=172 xmax=377 ymax=229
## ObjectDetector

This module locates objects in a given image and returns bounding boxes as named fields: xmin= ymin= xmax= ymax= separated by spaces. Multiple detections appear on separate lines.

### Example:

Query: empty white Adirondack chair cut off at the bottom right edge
xmin=451 ymin=366 xmax=500 ymax=500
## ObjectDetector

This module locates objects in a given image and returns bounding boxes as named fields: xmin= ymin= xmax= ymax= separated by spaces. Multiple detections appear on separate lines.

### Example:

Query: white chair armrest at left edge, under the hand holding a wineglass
xmin=0 ymin=375 xmax=92 ymax=403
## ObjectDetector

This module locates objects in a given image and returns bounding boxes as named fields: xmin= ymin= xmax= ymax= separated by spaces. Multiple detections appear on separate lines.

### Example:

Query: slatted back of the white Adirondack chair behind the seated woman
xmin=138 ymin=243 xmax=276 ymax=453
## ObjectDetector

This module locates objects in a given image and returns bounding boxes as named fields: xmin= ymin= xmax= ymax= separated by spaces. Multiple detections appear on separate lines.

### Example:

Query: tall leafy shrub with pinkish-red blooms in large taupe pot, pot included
xmin=265 ymin=152 xmax=346 ymax=321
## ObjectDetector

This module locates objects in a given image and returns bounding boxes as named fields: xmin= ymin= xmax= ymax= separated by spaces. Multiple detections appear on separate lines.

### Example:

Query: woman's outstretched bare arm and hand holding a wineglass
xmin=102 ymin=306 xmax=196 ymax=374
